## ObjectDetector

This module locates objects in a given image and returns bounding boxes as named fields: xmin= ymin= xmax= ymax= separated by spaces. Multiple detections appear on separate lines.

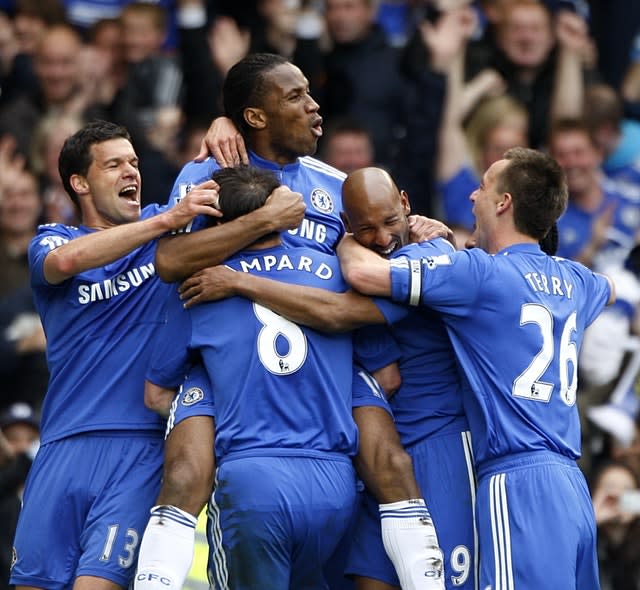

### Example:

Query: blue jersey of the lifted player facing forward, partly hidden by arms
xmin=169 ymin=152 xmax=346 ymax=254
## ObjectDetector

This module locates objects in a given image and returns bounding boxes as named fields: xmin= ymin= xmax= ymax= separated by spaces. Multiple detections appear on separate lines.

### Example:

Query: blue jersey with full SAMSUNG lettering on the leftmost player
xmin=29 ymin=205 xmax=169 ymax=443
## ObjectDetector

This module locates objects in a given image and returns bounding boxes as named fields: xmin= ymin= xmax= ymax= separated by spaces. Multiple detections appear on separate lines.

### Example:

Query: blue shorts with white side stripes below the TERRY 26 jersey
xmin=476 ymin=451 xmax=600 ymax=590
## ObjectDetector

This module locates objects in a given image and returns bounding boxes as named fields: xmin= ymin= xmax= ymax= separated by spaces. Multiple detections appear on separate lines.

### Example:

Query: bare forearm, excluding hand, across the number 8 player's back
xmin=234 ymin=273 xmax=385 ymax=332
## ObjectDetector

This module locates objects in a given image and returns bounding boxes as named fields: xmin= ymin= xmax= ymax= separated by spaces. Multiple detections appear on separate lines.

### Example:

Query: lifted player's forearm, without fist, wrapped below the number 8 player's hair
xmin=156 ymin=209 xmax=273 ymax=283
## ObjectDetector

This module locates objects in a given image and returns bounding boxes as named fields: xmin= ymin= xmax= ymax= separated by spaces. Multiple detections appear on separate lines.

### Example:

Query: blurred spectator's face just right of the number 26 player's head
xmin=549 ymin=129 xmax=602 ymax=194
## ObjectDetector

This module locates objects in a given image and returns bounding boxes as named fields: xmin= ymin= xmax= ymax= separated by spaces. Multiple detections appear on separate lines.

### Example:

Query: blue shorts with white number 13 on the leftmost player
xmin=11 ymin=431 xmax=163 ymax=590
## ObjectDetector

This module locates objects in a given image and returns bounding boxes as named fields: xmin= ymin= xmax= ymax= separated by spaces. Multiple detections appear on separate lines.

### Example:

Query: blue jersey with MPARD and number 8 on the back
xmin=147 ymin=246 xmax=358 ymax=459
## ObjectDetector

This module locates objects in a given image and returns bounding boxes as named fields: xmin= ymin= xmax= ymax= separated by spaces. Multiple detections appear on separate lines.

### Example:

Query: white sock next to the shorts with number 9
xmin=379 ymin=498 xmax=444 ymax=590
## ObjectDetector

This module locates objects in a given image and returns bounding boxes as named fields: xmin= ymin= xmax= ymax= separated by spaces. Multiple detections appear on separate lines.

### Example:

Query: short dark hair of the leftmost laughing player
xmin=58 ymin=120 xmax=131 ymax=206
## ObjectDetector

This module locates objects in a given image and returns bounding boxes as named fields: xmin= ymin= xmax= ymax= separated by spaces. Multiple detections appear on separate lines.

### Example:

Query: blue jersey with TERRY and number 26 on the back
xmin=391 ymin=244 xmax=610 ymax=463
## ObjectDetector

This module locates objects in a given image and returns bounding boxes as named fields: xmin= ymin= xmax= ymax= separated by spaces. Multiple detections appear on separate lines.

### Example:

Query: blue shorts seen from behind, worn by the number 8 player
xmin=207 ymin=455 xmax=356 ymax=590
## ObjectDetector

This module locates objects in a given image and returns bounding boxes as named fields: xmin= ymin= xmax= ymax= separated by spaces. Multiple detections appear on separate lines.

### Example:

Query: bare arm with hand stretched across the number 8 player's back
xmin=180 ymin=266 xmax=385 ymax=332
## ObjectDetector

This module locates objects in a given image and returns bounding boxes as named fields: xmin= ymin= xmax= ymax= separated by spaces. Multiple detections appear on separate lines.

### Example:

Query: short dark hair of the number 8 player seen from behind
xmin=212 ymin=166 xmax=280 ymax=221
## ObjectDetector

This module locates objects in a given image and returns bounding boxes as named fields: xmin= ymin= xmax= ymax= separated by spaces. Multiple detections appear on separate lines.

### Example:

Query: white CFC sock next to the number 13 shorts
xmin=133 ymin=506 xmax=198 ymax=590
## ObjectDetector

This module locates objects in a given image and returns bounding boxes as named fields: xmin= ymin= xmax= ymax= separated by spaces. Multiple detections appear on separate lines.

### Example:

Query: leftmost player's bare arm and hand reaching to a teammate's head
xmin=44 ymin=180 xmax=220 ymax=285
